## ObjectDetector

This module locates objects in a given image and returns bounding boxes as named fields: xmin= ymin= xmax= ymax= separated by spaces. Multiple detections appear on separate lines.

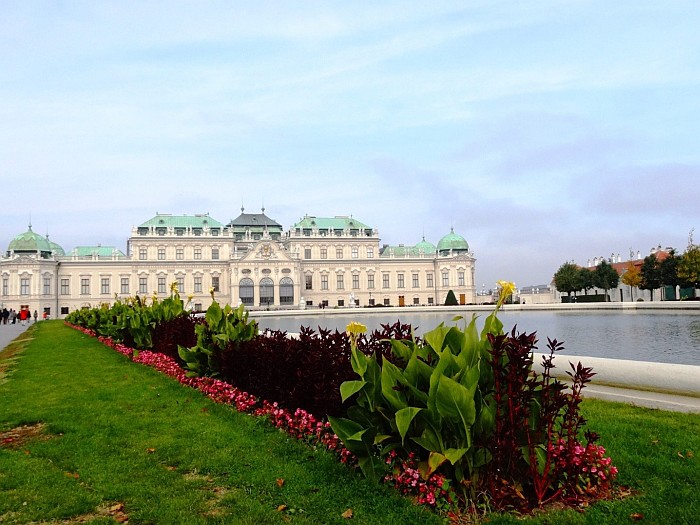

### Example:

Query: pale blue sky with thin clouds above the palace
xmin=0 ymin=0 xmax=700 ymax=289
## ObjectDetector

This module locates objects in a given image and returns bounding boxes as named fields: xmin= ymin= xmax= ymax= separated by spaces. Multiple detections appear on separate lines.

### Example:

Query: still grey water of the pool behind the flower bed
xmin=257 ymin=311 xmax=700 ymax=365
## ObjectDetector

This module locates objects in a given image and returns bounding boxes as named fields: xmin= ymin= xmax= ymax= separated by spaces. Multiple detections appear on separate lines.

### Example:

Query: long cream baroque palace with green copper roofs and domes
xmin=0 ymin=208 xmax=476 ymax=318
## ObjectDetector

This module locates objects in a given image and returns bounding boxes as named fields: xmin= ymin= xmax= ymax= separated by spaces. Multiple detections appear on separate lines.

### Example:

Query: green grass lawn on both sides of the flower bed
xmin=0 ymin=321 xmax=700 ymax=525
